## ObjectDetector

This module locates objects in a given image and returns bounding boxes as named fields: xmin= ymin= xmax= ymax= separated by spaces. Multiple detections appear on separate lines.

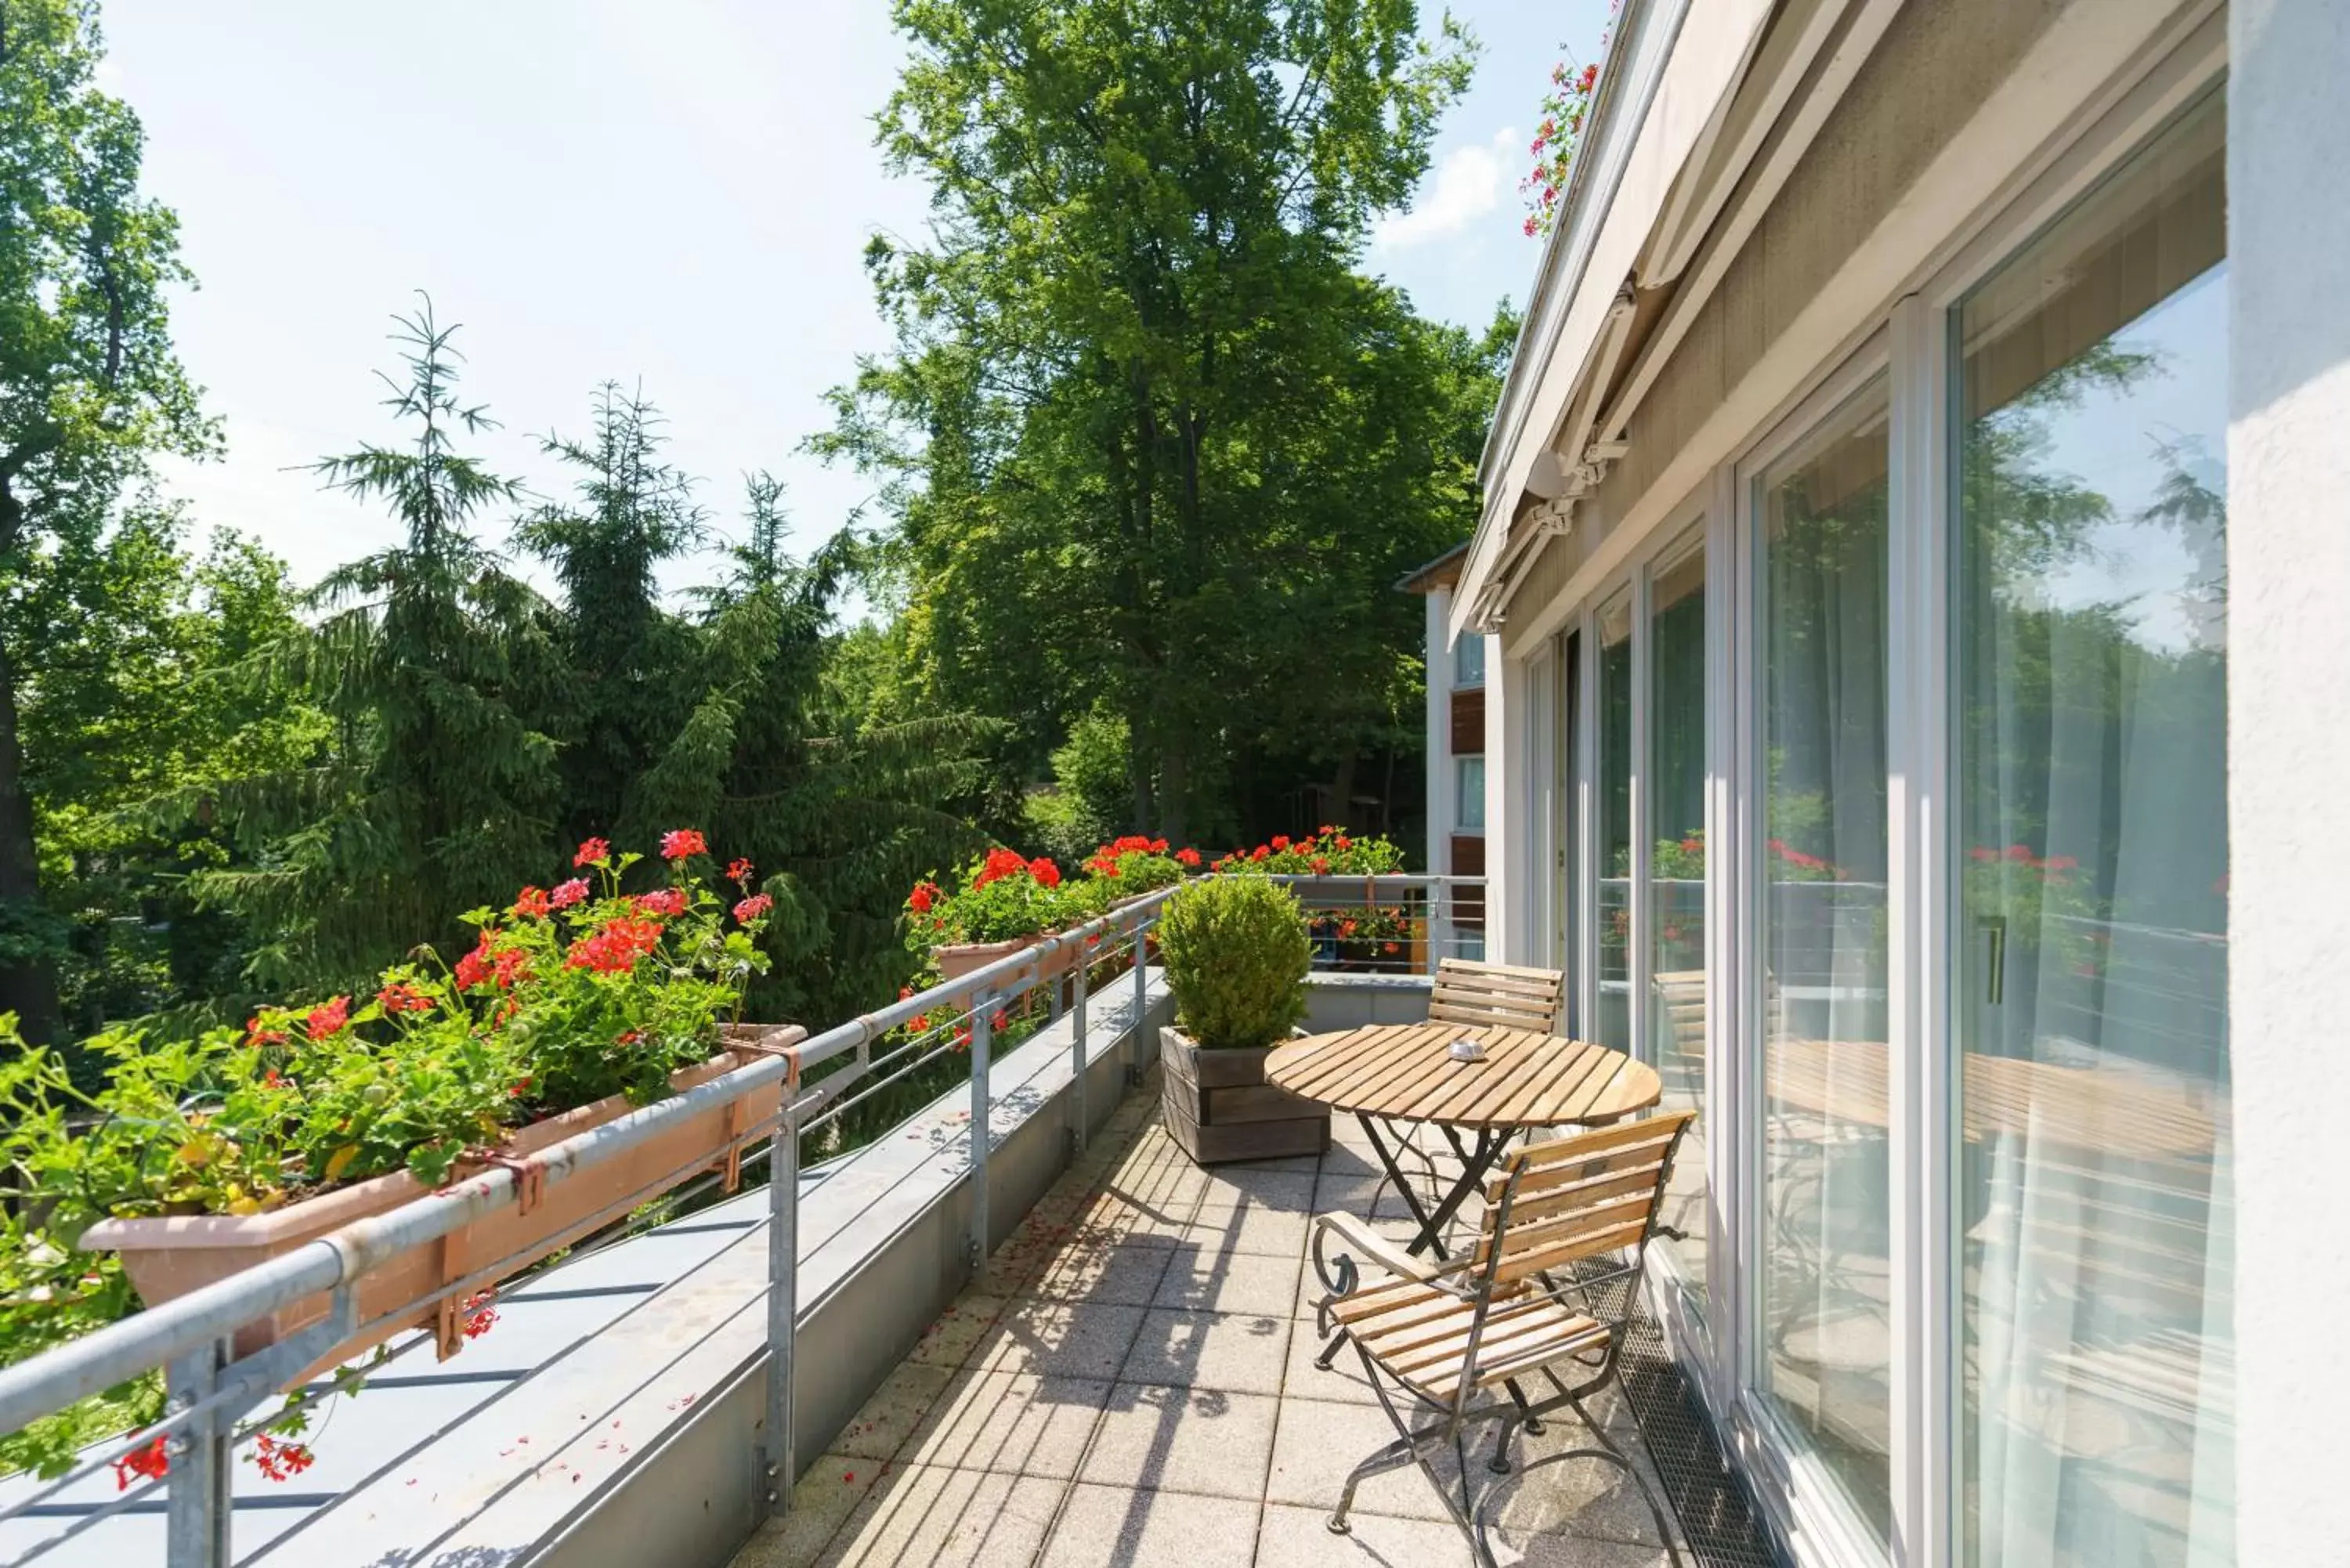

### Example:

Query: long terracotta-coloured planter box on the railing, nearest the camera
xmin=82 ymin=1025 xmax=808 ymax=1378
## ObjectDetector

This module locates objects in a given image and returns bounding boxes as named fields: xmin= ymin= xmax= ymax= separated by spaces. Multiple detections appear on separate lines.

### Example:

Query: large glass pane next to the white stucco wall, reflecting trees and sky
xmin=1953 ymin=85 xmax=2232 ymax=1568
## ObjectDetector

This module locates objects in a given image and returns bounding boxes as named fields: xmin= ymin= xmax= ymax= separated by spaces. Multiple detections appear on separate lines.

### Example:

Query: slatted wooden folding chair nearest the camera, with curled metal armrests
xmin=1314 ymin=1112 xmax=1694 ymax=1568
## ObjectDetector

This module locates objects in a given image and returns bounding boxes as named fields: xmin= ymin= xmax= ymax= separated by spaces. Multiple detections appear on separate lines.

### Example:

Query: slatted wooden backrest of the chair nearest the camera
xmin=1473 ymin=1112 xmax=1697 ymax=1295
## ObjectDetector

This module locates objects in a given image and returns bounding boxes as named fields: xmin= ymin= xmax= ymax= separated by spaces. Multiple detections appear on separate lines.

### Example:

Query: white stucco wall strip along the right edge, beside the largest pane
xmin=2228 ymin=0 xmax=2350 ymax=1568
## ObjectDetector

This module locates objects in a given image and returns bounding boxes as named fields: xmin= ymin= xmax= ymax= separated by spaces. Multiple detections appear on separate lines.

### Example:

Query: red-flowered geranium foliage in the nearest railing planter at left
xmin=0 ymin=830 xmax=773 ymax=1474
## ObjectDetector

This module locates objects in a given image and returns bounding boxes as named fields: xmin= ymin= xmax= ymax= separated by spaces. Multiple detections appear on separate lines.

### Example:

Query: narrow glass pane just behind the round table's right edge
xmin=1645 ymin=531 xmax=1706 ymax=1310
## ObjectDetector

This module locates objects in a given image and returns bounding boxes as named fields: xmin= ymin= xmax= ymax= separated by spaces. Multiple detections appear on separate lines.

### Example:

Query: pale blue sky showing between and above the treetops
xmin=101 ymin=0 xmax=1605 ymax=594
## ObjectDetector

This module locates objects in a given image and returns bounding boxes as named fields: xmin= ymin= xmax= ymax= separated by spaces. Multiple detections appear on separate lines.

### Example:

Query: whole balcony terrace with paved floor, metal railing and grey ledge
xmin=0 ymin=880 xmax=1770 ymax=1568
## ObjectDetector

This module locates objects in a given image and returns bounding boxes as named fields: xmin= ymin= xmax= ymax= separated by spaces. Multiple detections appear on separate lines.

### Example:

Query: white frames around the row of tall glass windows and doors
xmin=1488 ymin=15 xmax=2228 ymax=1568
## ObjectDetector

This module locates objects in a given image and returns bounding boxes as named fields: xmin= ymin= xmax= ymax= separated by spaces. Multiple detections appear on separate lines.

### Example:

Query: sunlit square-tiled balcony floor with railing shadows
xmin=736 ymin=1084 xmax=1687 ymax=1568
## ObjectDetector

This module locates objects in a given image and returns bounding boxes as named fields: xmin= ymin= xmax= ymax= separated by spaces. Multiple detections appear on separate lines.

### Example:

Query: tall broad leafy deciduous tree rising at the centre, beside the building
xmin=820 ymin=0 xmax=1483 ymax=837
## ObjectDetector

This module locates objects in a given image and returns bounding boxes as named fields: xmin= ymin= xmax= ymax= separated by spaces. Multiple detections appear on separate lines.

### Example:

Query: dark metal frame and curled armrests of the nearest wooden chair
xmin=1314 ymin=1112 xmax=1694 ymax=1568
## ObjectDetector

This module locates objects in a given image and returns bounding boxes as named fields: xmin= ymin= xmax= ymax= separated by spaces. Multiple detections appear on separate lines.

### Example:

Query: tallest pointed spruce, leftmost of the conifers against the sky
xmin=200 ymin=301 xmax=562 ymax=985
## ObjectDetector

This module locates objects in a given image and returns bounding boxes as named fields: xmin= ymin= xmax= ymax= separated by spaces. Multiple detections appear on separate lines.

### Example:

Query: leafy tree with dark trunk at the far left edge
xmin=0 ymin=0 xmax=214 ymax=1042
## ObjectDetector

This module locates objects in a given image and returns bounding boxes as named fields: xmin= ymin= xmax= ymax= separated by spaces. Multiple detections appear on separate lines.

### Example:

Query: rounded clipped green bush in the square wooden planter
xmin=1159 ymin=877 xmax=1311 ymax=1051
